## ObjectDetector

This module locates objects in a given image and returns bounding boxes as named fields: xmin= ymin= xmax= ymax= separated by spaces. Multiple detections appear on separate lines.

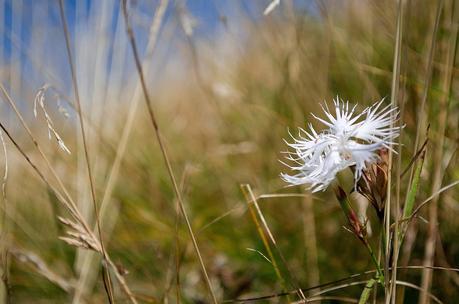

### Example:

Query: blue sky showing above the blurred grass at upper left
xmin=0 ymin=0 xmax=315 ymax=105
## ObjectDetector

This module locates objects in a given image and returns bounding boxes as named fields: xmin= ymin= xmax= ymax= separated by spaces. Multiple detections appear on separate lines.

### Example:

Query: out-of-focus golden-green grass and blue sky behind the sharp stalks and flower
xmin=0 ymin=0 xmax=459 ymax=303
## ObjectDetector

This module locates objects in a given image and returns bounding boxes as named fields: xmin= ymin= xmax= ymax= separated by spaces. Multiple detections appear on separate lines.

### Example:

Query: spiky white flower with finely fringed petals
xmin=281 ymin=97 xmax=400 ymax=192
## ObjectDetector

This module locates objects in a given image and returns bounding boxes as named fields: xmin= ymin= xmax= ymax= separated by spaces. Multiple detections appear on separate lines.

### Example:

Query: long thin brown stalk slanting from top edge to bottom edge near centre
xmin=120 ymin=0 xmax=217 ymax=304
